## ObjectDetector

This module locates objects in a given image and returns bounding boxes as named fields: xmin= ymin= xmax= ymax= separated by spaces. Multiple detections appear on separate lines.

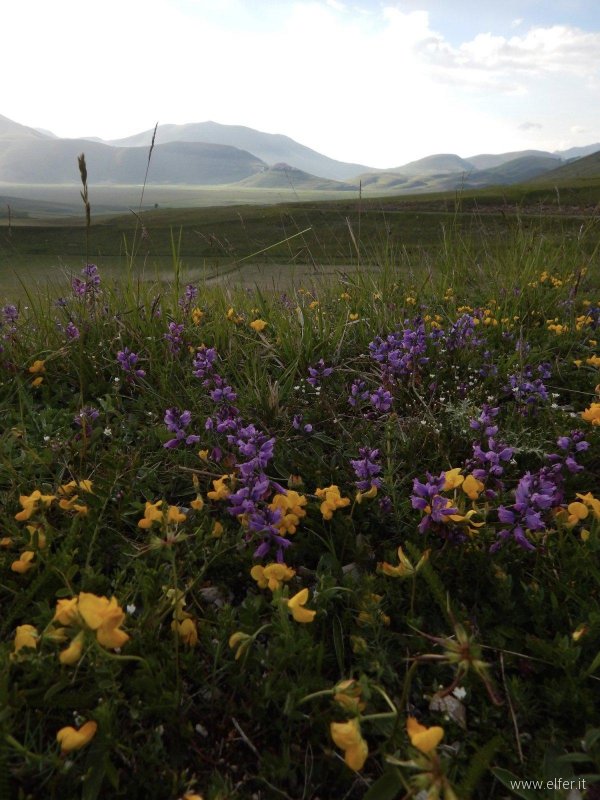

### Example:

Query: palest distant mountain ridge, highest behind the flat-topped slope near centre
xmin=109 ymin=122 xmax=370 ymax=181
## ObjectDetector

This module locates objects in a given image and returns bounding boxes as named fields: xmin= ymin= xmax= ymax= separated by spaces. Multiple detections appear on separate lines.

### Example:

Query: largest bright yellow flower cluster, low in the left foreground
xmin=53 ymin=592 xmax=129 ymax=666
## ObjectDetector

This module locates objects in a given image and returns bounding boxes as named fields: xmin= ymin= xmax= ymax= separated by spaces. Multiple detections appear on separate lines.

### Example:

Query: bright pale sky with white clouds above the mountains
xmin=0 ymin=0 xmax=600 ymax=168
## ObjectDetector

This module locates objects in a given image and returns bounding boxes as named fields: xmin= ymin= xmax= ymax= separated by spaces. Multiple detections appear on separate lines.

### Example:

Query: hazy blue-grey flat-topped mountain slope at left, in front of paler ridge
xmin=0 ymin=137 xmax=266 ymax=185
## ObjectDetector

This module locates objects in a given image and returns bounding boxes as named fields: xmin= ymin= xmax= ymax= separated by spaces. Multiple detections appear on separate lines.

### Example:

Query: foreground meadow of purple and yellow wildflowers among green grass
xmin=0 ymin=247 xmax=600 ymax=800
